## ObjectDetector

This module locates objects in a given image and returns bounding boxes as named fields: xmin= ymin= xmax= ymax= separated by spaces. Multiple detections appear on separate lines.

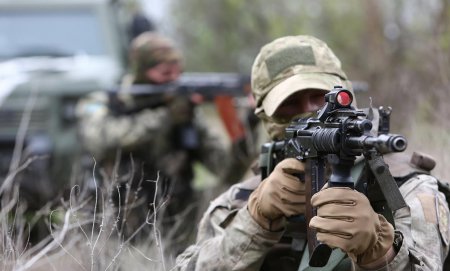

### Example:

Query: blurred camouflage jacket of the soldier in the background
xmin=76 ymin=85 xmax=228 ymax=184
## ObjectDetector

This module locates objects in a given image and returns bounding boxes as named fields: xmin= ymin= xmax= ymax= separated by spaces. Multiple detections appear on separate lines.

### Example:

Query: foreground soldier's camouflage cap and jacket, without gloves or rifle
xmin=174 ymin=36 xmax=450 ymax=271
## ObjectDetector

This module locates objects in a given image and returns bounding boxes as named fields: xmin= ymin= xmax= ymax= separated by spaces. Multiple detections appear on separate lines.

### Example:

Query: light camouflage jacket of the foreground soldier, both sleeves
xmin=175 ymin=154 xmax=449 ymax=271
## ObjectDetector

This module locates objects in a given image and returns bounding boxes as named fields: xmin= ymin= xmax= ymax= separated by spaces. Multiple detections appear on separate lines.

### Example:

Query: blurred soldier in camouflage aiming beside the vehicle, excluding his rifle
xmin=77 ymin=32 xmax=236 ymax=255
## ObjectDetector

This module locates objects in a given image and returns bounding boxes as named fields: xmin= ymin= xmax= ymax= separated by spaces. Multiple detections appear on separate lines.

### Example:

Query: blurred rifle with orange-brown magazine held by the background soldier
xmin=108 ymin=72 xmax=253 ymax=141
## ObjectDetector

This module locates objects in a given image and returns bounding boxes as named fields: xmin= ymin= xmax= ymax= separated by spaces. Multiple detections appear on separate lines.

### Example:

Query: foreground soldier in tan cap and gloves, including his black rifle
xmin=175 ymin=36 xmax=449 ymax=271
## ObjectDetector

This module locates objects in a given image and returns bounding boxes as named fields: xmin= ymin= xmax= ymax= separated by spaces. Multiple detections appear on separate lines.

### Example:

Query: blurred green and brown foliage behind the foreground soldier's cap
xmin=163 ymin=0 xmax=450 ymax=179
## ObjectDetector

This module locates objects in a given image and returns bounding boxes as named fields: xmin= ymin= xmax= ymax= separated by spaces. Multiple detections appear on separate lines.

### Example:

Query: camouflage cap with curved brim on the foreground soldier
xmin=251 ymin=36 xmax=352 ymax=117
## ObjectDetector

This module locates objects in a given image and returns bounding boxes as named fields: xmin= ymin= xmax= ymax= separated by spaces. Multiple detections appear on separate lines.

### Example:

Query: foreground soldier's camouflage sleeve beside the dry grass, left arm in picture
xmin=172 ymin=186 xmax=283 ymax=271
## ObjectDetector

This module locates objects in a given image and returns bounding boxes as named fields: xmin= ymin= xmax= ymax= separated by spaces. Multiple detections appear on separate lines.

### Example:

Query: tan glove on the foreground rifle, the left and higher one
xmin=248 ymin=158 xmax=305 ymax=231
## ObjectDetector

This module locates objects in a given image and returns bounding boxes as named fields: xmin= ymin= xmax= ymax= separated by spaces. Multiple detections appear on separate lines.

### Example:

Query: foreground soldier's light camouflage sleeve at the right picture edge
xmin=356 ymin=175 xmax=449 ymax=270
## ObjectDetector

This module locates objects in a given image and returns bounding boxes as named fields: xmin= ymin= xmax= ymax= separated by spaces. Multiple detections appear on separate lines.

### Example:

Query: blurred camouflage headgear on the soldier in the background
xmin=129 ymin=31 xmax=182 ymax=82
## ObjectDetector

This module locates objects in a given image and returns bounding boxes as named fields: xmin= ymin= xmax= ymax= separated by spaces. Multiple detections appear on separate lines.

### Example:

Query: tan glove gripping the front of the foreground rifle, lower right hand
xmin=309 ymin=187 xmax=394 ymax=265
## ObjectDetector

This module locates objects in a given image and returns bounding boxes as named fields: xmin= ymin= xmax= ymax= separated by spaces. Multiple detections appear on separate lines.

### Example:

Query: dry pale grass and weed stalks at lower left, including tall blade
xmin=0 ymin=75 xmax=215 ymax=271
